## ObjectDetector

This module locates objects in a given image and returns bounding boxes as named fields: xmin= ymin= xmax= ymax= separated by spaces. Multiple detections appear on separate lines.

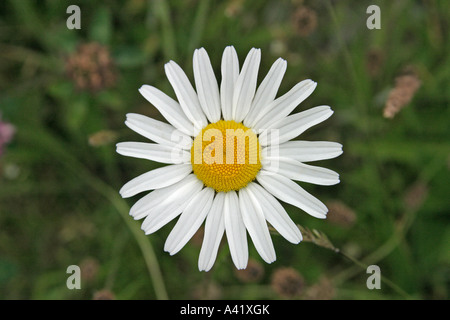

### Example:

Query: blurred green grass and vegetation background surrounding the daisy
xmin=0 ymin=0 xmax=450 ymax=299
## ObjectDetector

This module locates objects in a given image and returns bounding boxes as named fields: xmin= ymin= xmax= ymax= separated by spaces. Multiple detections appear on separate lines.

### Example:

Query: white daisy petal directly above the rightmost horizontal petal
xmin=259 ymin=106 xmax=333 ymax=146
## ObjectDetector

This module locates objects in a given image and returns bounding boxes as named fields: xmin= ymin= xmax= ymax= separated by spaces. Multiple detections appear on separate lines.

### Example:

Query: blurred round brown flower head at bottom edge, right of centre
xmin=271 ymin=267 xmax=304 ymax=298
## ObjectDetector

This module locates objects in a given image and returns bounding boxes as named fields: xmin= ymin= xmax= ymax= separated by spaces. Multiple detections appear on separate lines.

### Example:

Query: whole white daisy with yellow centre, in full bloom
xmin=117 ymin=46 xmax=342 ymax=271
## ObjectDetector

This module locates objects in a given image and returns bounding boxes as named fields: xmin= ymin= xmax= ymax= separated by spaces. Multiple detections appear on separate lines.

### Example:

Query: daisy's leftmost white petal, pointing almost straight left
xmin=116 ymin=142 xmax=191 ymax=164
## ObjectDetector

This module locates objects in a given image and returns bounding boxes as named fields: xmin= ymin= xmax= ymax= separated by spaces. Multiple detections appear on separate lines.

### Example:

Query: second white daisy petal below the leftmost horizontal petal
xmin=130 ymin=173 xmax=203 ymax=220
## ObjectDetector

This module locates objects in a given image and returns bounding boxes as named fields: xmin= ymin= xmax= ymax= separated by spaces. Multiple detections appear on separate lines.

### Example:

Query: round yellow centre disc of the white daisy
xmin=191 ymin=120 xmax=261 ymax=192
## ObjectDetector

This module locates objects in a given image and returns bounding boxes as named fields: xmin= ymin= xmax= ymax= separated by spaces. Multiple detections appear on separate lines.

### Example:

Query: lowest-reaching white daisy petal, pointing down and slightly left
xmin=198 ymin=192 xmax=225 ymax=271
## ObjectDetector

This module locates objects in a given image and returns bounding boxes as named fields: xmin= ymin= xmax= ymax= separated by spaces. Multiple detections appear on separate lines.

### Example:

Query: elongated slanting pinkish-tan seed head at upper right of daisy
xmin=383 ymin=71 xmax=421 ymax=119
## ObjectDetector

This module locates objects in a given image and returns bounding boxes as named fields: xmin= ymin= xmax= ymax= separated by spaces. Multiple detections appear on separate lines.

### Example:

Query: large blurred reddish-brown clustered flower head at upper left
xmin=66 ymin=42 xmax=117 ymax=92
